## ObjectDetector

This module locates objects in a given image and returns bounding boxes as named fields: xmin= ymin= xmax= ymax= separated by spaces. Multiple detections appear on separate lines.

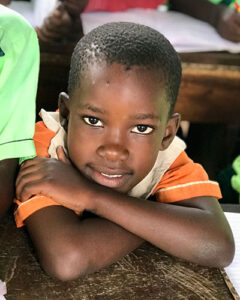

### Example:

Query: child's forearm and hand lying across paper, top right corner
xmin=170 ymin=0 xmax=240 ymax=42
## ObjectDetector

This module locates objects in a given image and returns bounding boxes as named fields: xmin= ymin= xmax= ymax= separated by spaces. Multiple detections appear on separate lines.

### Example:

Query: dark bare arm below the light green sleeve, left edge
xmin=0 ymin=158 xmax=18 ymax=217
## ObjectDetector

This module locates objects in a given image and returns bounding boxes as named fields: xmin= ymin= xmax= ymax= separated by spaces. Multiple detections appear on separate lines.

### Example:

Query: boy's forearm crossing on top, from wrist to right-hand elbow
xmin=86 ymin=190 xmax=233 ymax=266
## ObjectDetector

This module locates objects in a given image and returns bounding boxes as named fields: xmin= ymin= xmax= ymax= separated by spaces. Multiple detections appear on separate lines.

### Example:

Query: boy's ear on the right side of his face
xmin=160 ymin=113 xmax=181 ymax=151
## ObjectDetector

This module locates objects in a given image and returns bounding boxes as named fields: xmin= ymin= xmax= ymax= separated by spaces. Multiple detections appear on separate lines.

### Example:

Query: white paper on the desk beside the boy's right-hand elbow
xmin=225 ymin=213 xmax=240 ymax=295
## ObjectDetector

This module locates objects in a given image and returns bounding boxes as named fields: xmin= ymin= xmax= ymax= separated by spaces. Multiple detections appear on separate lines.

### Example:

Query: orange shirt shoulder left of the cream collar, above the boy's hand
xmin=33 ymin=121 xmax=56 ymax=157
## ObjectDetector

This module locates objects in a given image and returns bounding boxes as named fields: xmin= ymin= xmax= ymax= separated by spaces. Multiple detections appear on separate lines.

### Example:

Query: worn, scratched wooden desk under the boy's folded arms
xmin=0 ymin=210 xmax=236 ymax=300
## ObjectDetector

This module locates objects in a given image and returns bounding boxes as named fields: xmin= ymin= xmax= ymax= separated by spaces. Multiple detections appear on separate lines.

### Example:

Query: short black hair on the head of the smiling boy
xmin=68 ymin=22 xmax=182 ymax=113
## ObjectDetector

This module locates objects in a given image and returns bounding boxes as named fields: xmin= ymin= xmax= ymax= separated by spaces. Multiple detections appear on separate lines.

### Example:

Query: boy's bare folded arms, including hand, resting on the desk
xmin=17 ymin=150 xmax=234 ymax=278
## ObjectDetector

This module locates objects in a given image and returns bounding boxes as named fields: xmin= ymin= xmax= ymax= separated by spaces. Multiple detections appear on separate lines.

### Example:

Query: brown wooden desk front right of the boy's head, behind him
xmin=175 ymin=63 xmax=240 ymax=124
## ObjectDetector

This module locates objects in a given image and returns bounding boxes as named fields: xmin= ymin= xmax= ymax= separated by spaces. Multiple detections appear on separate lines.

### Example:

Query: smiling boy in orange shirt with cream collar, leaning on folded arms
xmin=15 ymin=22 xmax=234 ymax=280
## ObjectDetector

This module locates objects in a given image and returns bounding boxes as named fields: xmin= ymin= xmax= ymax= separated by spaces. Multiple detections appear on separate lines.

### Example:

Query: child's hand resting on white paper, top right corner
xmin=216 ymin=8 xmax=240 ymax=42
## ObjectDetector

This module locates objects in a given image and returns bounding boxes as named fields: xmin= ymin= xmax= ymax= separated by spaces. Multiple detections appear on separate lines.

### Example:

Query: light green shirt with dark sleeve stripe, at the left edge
xmin=0 ymin=5 xmax=39 ymax=160
